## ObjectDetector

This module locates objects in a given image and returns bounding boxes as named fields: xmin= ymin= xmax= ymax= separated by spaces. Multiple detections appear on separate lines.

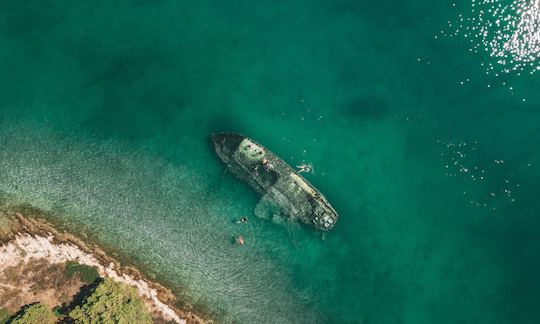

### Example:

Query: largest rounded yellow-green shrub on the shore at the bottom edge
xmin=69 ymin=279 xmax=152 ymax=324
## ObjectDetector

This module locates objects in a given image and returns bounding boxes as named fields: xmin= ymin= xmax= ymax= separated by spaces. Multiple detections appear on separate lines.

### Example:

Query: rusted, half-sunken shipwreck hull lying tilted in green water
xmin=212 ymin=133 xmax=338 ymax=231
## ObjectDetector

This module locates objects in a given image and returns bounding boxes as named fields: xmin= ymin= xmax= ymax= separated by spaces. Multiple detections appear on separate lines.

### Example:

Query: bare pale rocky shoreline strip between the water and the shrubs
xmin=0 ymin=211 xmax=211 ymax=324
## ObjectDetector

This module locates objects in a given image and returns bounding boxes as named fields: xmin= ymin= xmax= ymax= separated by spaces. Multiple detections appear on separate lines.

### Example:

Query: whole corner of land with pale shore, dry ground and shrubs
xmin=0 ymin=210 xmax=203 ymax=324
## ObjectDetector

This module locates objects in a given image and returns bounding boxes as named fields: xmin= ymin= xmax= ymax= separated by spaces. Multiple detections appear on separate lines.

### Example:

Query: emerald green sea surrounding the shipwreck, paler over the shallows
xmin=0 ymin=0 xmax=540 ymax=323
